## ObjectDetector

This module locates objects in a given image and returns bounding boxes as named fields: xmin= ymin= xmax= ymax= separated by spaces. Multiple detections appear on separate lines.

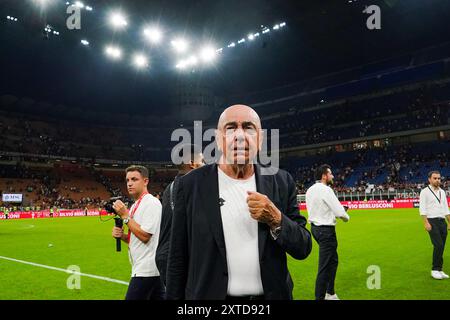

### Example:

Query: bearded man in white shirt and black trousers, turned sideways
xmin=306 ymin=164 xmax=350 ymax=300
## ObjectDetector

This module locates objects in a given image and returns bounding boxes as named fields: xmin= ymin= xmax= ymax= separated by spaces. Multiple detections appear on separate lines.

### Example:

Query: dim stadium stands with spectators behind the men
xmin=0 ymin=46 xmax=450 ymax=208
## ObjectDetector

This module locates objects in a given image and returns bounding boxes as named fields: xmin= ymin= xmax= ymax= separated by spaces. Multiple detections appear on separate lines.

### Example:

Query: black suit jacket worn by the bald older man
xmin=167 ymin=164 xmax=311 ymax=300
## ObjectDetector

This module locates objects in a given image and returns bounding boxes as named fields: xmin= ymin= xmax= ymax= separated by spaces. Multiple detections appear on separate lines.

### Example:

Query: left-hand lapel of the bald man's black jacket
xmin=201 ymin=164 xmax=226 ymax=262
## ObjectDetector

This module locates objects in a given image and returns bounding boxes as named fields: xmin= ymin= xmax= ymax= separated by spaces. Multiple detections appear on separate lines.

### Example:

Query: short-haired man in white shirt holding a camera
xmin=112 ymin=166 xmax=164 ymax=300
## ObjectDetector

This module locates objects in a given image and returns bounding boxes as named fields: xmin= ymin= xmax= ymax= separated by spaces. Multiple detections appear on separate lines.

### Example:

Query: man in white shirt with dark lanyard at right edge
xmin=419 ymin=171 xmax=450 ymax=280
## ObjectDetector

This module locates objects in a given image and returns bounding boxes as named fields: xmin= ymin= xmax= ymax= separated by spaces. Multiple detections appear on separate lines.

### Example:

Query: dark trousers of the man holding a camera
xmin=125 ymin=277 xmax=164 ymax=300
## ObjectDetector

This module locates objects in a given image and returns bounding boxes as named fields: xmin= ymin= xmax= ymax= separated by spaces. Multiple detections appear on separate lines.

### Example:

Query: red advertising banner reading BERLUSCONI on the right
xmin=299 ymin=197 xmax=450 ymax=211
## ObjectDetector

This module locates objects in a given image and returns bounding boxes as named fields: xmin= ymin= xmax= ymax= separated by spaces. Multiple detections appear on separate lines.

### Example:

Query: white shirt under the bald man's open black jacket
xmin=218 ymin=168 xmax=264 ymax=296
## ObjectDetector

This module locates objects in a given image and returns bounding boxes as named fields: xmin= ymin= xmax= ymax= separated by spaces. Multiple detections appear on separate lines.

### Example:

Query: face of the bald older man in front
xmin=216 ymin=109 xmax=262 ymax=165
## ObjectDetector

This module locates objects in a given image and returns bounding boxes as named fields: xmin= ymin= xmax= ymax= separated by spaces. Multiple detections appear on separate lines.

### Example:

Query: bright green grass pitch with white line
xmin=0 ymin=209 xmax=450 ymax=300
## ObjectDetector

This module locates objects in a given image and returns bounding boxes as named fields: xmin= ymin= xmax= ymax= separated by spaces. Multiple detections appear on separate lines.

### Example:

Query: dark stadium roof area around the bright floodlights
xmin=0 ymin=0 xmax=450 ymax=115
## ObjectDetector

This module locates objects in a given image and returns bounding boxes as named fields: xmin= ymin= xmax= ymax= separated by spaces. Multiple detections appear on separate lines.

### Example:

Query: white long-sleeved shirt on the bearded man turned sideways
xmin=306 ymin=181 xmax=350 ymax=226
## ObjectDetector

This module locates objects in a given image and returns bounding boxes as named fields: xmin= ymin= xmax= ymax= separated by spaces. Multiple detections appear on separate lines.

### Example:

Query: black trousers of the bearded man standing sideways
xmin=311 ymin=224 xmax=338 ymax=300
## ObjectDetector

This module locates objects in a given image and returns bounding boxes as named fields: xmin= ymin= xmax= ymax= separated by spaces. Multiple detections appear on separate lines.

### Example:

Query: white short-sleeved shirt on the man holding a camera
xmin=128 ymin=194 xmax=162 ymax=277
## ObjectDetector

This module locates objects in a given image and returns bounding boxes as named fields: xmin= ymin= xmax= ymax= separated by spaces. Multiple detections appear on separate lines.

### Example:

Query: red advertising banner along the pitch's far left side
xmin=0 ymin=209 xmax=107 ymax=220
